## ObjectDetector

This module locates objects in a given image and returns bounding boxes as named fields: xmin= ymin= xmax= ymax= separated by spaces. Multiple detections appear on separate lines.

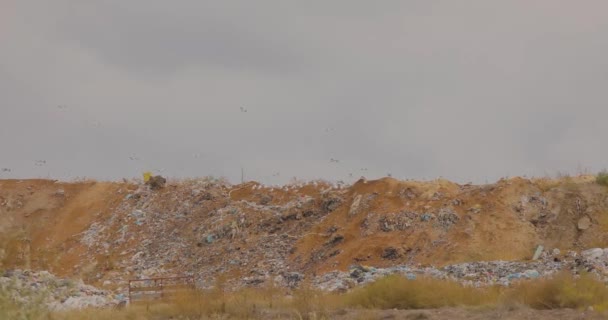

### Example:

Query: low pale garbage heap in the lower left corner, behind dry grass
xmin=0 ymin=270 xmax=123 ymax=311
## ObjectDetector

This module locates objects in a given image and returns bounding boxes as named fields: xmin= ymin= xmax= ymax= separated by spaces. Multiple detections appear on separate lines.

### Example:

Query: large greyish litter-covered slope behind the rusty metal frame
xmin=77 ymin=178 xmax=341 ymax=290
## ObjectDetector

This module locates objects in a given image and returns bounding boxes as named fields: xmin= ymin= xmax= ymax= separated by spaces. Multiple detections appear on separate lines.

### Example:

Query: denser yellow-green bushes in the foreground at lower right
xmin=345 ymin=272 xmax=608 ymax=311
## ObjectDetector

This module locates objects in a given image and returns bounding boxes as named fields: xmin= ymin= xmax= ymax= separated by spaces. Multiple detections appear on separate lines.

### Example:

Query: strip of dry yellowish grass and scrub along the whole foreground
xmin=0 ymin=273 xmax=608 ymax=320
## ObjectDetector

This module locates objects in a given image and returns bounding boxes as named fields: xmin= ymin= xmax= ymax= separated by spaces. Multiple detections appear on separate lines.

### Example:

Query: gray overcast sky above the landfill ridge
xmin=0 ymin=0 xmax=608 ymax=183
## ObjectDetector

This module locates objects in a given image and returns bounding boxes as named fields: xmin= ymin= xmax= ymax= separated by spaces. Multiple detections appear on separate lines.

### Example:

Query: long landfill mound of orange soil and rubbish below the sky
xmin=0 ymin=176 xmax=608 ymax=291
